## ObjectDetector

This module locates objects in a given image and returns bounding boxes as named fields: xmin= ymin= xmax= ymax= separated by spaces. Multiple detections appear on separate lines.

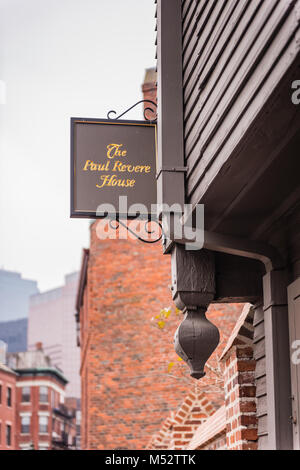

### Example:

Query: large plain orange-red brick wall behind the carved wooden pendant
xmin=77 ymin=222 xmax=242 ymax=449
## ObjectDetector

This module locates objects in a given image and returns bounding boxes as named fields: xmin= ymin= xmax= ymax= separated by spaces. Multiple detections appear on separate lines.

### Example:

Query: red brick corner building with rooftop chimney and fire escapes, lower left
xmin=6 ymin=343 xmax=76 ymax=450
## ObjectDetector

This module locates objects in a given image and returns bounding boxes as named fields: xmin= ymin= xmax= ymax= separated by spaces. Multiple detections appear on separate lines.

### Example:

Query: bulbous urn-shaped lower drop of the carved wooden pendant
xmin=174 ymin=307 xmax=220 ymax=380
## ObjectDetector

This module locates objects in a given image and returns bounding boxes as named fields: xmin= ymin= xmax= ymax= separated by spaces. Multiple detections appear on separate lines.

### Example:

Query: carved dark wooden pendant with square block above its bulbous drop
xmin=172 ymin=244 xmax=220 ymax=379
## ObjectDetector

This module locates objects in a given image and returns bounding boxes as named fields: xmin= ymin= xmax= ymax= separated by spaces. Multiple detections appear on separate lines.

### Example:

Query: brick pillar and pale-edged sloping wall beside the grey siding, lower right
xmin=186 ymin=304 xmax=257 ymax=450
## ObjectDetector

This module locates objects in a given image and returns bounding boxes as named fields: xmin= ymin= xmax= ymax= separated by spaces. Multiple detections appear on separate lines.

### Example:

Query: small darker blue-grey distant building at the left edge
xmin=0 ymin=318 xmax=28 ymax=352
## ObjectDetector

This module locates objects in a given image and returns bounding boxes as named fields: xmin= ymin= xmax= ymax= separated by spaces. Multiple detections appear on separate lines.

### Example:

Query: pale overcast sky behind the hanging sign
xmin=0 ymin=0 xmax=155 ymax=290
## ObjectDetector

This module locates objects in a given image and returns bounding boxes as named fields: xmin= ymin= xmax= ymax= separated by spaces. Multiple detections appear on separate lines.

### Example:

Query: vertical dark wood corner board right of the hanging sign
xmin=157 ymin=0 xmax=185 ymax=212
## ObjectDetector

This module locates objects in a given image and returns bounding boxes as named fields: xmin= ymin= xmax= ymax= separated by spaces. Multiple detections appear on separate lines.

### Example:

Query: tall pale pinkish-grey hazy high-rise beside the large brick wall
xmin=28 ymin=273 xmax=80 ymax=398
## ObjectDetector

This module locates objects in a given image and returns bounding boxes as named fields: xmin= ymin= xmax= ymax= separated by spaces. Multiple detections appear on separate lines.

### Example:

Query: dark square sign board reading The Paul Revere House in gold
xmin=71 ymin=118 xmax=156 ymax=219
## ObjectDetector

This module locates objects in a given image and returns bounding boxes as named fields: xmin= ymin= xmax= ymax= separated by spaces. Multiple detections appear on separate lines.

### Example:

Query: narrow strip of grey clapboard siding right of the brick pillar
xmin=253 ymin=306 xmax=268 ymax=450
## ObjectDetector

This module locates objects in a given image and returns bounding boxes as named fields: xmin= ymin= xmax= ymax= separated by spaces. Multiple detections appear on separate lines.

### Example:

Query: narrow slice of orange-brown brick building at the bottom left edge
xmin=0 ymin=363 xmax=17 ymax=450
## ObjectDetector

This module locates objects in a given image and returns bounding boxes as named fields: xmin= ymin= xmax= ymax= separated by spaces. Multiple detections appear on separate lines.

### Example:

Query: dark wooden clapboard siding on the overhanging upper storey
xmin=182 ymin=0 xmax=300 ymax=207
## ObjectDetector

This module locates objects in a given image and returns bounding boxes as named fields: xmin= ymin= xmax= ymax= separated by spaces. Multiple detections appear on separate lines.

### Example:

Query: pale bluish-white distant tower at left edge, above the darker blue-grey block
xmin=0 ymin=269 xmax=39 ymax=324
